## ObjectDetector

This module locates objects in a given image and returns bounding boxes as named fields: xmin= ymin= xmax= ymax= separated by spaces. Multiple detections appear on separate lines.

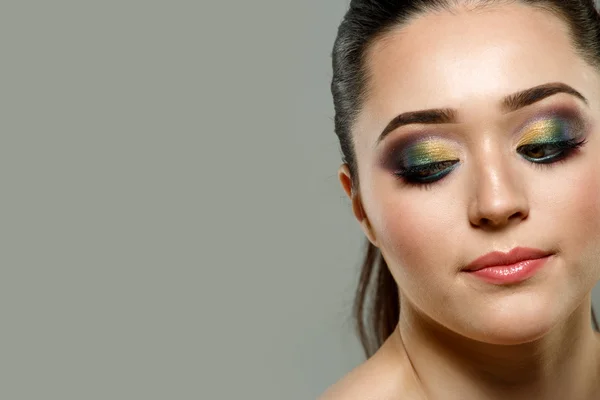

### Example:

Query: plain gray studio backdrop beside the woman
xmin=0 ymin=0 xmax=600 ymax=400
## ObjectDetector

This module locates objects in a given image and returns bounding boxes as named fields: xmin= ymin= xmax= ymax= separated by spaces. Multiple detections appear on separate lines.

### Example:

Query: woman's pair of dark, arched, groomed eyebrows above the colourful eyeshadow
xmin=376 ymin=82 xmax=589 ymax=145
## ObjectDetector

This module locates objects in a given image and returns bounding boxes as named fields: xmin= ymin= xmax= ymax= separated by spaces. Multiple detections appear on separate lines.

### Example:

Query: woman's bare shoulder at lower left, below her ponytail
xmin=318 ymin=334 xmax=424 ymax=400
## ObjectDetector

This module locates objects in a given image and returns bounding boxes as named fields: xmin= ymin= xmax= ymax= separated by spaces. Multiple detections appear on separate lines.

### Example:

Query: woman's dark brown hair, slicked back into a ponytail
xmin=331 ymin=0 xmax=600 ymax=357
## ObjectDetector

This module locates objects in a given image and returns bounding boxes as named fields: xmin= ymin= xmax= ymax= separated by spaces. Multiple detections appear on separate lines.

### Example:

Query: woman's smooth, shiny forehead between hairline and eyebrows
xmin=358 ymin=3 xmax=591 ymax=138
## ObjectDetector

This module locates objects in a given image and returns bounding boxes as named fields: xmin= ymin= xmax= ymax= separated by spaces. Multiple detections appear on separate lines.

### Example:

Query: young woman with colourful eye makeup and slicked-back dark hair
xmin=322 ymin=0 xmax=600 ymax=400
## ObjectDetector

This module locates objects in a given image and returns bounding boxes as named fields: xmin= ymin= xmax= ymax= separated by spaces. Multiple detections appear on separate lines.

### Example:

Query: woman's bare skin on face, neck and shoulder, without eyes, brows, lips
xmin=321 ymin=3 xmax=600 ymax=400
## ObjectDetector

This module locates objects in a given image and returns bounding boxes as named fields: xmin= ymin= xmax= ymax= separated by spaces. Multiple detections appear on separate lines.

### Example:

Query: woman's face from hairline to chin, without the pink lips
xmin=340 ymin=4 xmax=600 ymax=344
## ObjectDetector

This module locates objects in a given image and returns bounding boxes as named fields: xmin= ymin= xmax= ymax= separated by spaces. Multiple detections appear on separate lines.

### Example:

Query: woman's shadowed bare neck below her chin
xmin=395 ymin=295 xmax=600 ymax=400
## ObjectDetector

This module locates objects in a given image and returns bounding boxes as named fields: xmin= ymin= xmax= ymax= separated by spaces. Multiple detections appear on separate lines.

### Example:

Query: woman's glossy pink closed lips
xmin=463 ymin=247 xmax=552 ymax=285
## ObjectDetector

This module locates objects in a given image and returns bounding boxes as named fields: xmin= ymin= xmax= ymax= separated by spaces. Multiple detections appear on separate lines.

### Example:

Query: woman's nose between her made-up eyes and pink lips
xmin=469 ymin=153 xmax=529 ymax=229
